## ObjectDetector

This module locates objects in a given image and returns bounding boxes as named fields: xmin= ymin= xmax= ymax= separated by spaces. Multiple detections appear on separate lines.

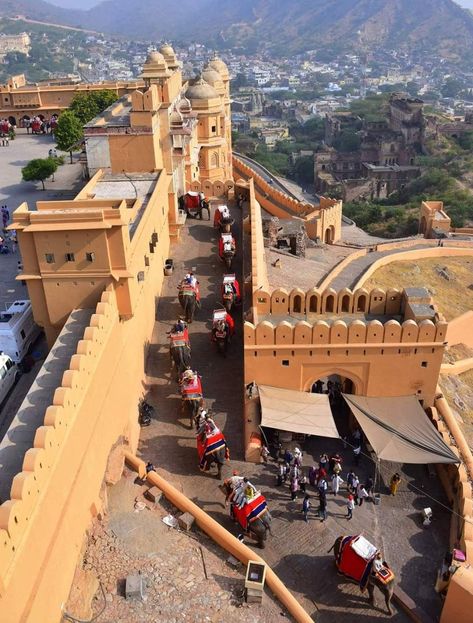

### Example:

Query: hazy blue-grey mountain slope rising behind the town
xmin=0 ymin=0 xmax=473 ymax=60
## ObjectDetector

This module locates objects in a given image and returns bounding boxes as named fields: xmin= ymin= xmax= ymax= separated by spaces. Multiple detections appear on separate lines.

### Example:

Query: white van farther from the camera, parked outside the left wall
xmin=0 ymin=299 xmax=41 ymax=363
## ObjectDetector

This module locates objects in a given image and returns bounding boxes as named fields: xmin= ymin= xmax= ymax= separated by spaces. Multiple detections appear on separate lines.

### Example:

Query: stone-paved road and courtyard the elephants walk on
xmin=78 ymin=202 xmax=450 ymax=623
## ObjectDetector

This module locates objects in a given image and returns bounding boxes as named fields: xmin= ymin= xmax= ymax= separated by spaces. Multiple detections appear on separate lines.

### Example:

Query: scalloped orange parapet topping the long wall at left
xmin=0 ymin=287 xmax=119 ymax=595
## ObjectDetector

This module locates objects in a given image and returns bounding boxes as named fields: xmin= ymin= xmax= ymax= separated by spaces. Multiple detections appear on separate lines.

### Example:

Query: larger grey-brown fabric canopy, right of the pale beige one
xmin=343 ymin=394 xmax=459 ymax=464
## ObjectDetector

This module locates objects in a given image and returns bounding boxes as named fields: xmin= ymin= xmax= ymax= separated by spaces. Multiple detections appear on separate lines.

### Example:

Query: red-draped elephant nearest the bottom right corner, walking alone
xmin=329 ymin=536 xmax=395 ymax=614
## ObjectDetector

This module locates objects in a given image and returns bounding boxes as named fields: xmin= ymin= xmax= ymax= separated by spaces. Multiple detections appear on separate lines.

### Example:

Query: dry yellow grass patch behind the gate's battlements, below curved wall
xmin=364 ymin=257 xmax=473 ymax=320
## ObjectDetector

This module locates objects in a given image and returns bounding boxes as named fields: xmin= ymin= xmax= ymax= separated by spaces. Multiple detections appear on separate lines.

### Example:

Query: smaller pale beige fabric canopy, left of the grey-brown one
xmin=258 ymin=385 xmax=340 ymax=438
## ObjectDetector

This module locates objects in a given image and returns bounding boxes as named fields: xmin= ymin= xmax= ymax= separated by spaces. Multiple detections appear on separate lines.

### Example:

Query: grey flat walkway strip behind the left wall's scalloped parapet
xmin=0 ymin=309 xmax=94 ymax=502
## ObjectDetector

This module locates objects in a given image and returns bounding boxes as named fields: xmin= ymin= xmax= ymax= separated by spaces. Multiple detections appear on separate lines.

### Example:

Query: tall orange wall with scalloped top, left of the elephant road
xmin=0 ymin=173 xmax=169 ymax=623
